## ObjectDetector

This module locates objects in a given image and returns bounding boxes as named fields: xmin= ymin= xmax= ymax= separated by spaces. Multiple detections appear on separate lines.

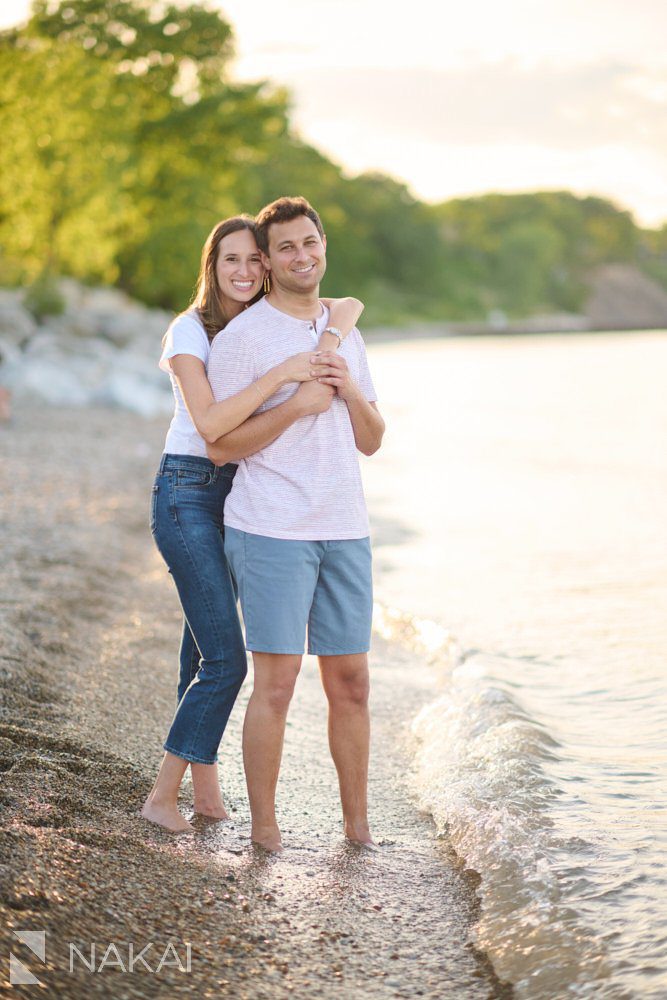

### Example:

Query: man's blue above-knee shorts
xmin=225 ymin=525 xmax=373 ymax=656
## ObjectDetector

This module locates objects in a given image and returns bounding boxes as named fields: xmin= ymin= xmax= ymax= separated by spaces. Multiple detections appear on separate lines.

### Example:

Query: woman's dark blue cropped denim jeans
xmin=151 ymin=455 xmax=248 ymax=764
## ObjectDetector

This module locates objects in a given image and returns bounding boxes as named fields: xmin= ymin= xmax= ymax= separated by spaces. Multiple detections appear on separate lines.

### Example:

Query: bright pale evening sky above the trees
xmin=5 ymin=0 xmax=667 ymax=225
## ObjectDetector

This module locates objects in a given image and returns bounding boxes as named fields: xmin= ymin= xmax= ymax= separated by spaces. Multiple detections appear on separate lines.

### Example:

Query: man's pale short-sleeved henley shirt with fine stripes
xmin=208 ymin=299 xmax=377 ymax=541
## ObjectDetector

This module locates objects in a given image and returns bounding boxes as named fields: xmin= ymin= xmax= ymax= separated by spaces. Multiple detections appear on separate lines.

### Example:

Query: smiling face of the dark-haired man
xmin=262 ymin=215 xmax=327 ymax=294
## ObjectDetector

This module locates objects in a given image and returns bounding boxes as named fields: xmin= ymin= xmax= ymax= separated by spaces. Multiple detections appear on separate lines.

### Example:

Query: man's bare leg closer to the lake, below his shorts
xmin=318 ymin=653 xmax=373 ymax=844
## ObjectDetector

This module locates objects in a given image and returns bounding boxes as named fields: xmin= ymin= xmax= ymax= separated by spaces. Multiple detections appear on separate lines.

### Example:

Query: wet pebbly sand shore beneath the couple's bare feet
xmin=0 ymin=403 xmax=512 ymax=1000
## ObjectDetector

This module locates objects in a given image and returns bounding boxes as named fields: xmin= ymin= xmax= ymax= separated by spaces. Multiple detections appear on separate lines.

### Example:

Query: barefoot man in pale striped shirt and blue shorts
xmin=208 ymin=198 xmax=384 ymax=850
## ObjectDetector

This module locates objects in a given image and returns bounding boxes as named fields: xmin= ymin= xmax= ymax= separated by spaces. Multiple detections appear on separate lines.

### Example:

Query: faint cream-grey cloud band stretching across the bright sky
xmin=289 ymin=60 xmax=667 ymax=155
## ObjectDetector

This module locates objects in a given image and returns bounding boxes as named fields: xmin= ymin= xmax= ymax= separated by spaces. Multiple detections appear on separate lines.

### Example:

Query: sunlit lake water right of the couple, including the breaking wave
xmin=364 ymin=331 xmax=667 ymax=1000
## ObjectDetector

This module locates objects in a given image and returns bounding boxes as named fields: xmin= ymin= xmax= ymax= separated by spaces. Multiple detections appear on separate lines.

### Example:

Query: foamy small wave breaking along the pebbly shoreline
xmin=375 ymin=609 xmax=616 ymax=1000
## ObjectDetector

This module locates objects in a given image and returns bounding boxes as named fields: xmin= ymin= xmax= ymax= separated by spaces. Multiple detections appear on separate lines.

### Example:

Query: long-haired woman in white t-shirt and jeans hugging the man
xmin=141 ymin=216 xmax=363 ymax=831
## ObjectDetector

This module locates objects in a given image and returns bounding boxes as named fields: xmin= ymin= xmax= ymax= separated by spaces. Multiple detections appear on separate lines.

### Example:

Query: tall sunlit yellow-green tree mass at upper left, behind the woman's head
xmin=0 ymin=0 xmax=286 ymax=308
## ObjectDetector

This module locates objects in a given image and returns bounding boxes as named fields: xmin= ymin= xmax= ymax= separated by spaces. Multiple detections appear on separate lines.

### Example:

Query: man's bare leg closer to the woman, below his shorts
xmin=243 ymin=653 xmax=301 ymax=851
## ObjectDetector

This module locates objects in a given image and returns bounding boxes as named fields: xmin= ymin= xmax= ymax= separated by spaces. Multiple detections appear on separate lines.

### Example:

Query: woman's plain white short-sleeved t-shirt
xmin=160 ymin=309 xmax=211 ymax=458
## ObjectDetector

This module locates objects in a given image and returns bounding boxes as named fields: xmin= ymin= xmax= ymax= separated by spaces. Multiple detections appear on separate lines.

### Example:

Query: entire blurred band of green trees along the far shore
xmin=0 ymin=0 xmax=667 ymax=322
